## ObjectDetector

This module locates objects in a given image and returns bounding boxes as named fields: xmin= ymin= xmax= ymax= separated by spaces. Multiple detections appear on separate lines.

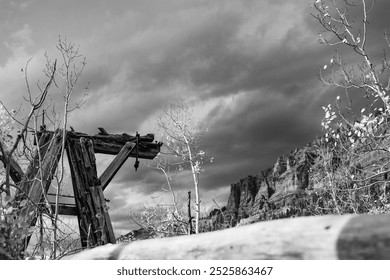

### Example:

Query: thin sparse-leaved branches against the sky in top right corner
xmin=314 ymin=0 xmax=390 ymax=112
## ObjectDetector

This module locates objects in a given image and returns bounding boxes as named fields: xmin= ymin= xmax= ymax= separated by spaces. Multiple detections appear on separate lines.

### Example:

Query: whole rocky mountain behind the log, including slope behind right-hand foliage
xmin=210 ymin=131 xmax=390 ymax=229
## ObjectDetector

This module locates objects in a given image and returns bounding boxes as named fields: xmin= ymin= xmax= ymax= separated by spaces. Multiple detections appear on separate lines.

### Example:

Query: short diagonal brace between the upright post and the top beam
xmin=99 ymin=142 xmax=136 ymax=191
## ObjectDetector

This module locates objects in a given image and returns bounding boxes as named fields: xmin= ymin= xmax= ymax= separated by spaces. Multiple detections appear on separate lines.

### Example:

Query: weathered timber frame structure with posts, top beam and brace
xmin=7 ymin=128 xmax=162 ymax=247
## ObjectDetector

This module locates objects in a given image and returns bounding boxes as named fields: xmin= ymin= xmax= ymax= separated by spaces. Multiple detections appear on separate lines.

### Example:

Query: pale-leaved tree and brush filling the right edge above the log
xmin=314 ymin=0 xmax=390 ymax=214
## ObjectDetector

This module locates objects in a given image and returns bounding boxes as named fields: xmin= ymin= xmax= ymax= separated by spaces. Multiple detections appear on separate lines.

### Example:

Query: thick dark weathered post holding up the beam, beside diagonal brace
xmin=66 ymin=137 xmax=115 ymax=247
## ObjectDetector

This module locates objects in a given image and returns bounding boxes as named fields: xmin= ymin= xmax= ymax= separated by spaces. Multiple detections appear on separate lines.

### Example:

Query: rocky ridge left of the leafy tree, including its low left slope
xmin=210 ymin=139 xmax=346 ymax=229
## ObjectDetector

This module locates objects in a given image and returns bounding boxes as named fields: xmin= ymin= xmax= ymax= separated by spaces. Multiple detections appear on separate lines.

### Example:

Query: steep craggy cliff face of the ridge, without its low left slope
xmin=224 ymin=144 xmax=320 ymax=226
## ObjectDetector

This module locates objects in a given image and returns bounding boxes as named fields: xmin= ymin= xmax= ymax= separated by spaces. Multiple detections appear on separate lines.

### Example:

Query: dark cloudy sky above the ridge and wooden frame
xmin=0 ymin=0 xmax=390 ymax=233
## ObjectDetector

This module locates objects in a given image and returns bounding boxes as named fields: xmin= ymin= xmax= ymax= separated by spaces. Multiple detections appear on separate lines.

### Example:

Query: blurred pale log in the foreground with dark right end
xmin=62 ymin=214 xmax=390 ymax=260
